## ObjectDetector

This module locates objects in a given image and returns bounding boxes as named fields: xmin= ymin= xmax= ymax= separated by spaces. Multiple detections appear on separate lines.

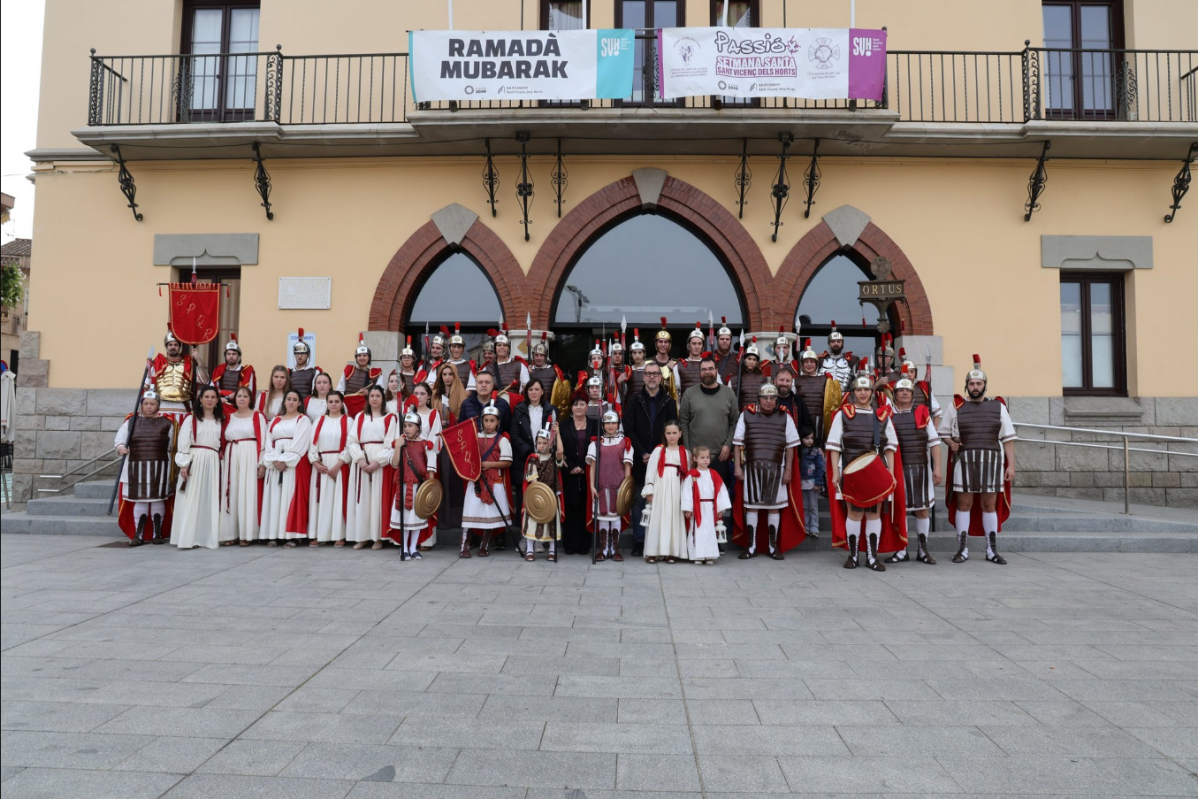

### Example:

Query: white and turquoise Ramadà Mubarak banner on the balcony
xmin=407 ymin=30 xmax=636 ymax=103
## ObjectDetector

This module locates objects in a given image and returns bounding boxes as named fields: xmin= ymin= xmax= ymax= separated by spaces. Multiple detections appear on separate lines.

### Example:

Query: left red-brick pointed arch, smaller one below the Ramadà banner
xmin=369 ymin=214 xmax=524 ymax=332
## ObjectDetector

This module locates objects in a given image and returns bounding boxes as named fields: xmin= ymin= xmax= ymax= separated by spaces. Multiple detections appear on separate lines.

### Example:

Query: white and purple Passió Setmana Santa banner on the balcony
xmin=658 ymin=28 xmax=887 ymax=101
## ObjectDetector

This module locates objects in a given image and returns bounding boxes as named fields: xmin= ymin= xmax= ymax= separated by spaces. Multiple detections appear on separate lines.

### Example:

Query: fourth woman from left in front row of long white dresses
xmin=308 ymin=390 xmax=350 ymax=546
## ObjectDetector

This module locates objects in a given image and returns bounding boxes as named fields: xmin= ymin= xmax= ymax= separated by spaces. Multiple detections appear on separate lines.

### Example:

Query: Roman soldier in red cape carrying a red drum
xmin=825 ymin=358 xmax=907 ymax=571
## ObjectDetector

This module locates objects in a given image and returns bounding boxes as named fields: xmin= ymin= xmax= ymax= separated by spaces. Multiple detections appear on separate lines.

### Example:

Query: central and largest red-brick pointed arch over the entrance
xmin=529 ymin=176 xmax=770 ymax=329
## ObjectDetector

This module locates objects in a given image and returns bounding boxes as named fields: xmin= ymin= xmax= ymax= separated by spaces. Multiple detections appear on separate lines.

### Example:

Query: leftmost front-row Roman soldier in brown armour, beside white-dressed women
xmin=114 ymin=391 xmax=179 ymax=546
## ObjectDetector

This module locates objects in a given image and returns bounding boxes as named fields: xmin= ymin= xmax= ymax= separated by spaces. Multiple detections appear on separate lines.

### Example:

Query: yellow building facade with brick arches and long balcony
xmin=17 ymin=0 xmax=1198 ymax=504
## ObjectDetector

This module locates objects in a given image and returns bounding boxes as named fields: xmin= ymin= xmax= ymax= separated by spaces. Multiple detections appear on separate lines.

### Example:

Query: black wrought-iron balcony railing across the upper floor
xmin=87 ymin=44 xmax=1198 ymax=127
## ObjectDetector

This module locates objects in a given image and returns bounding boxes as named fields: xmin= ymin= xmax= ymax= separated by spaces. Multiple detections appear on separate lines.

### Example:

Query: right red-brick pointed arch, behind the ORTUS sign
xmin=773 ymin=222 xmax=933 ymax=337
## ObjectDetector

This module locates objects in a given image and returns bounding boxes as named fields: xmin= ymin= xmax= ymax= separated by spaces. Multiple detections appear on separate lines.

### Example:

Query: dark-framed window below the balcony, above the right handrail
xmin=1060 ymin=272 xmax=1127 ymax=397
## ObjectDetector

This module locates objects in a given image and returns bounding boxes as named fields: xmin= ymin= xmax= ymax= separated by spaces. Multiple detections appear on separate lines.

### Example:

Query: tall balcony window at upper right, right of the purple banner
xmin=1041 ymin=0 xmax=1124 ymax=119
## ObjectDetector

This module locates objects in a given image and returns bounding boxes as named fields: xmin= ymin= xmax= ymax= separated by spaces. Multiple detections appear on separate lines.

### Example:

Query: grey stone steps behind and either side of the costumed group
xmin=0 ymin=480 xmax=1198 ymax=552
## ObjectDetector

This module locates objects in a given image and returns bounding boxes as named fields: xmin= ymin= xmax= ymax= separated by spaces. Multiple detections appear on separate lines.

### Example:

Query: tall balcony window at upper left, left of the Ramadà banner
xmin=181 ymin=0 xmax=259 ymax=121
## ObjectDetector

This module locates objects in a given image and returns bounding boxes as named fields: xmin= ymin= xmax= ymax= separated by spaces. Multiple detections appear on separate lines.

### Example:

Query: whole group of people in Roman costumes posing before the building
xmin=115 ymin=317 xmax=1015 ymax=571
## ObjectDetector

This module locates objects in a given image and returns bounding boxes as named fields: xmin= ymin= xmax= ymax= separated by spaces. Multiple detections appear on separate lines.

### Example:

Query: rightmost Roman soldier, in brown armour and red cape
xmin=942 ymin=355 xmax=1016 ymax=565
